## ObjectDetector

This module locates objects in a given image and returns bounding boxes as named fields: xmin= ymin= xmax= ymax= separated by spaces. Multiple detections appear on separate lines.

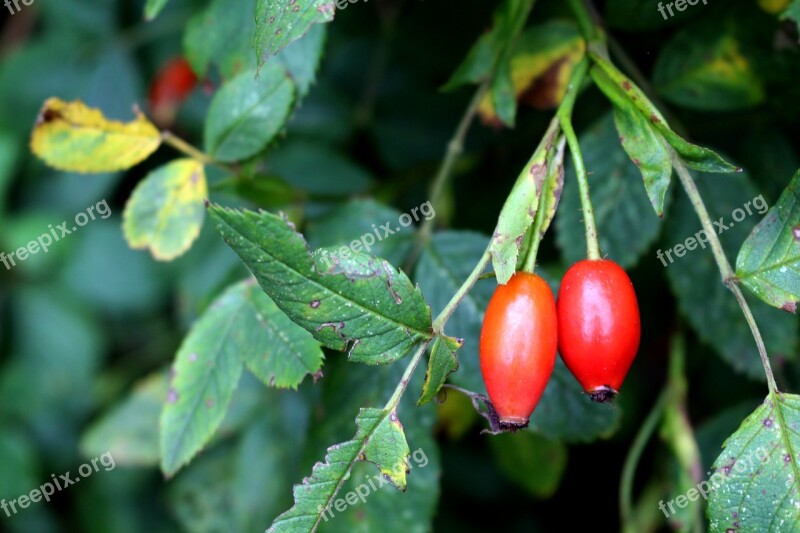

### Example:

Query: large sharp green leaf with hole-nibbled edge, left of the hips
xmin=209 ymin=206 xmax=432 ymax=364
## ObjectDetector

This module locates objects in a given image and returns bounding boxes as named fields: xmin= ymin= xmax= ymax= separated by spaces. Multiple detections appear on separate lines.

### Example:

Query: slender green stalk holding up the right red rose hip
xmin=556 ymin=56 xmax=600 ymax=260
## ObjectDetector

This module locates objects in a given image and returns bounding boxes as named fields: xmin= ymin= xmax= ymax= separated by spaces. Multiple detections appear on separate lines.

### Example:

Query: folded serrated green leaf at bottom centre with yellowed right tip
xmin=267 ymin=408 xmax=410 ymax=533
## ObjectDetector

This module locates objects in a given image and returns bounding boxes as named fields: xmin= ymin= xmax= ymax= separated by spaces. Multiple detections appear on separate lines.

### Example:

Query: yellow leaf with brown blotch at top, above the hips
xmin=478 ymin=21 xmax=586 ymax=123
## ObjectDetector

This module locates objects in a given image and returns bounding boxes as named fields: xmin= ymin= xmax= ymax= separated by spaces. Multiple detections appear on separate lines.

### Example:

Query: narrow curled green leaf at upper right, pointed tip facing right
xmin=589 ymin=57 xmax=740 ymax=173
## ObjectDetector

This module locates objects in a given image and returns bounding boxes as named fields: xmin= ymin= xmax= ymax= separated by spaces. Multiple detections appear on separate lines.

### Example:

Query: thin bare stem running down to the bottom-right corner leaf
xmin=670 ymin=149 xmax=778 ymax=395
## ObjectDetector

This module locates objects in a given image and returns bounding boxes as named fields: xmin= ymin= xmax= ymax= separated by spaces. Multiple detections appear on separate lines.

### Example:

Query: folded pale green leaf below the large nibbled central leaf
xmin=161 ymin=279 xmax=322 ymax=475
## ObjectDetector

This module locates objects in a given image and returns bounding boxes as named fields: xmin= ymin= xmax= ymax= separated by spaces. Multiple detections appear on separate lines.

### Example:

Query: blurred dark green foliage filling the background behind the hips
xmin=0 ymin=0 xmax=800 ymax=532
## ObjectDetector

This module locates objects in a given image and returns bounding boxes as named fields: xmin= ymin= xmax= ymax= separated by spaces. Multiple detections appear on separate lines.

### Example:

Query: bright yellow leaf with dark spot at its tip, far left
xmin=31 ymin=98 xmax=161 ymax=172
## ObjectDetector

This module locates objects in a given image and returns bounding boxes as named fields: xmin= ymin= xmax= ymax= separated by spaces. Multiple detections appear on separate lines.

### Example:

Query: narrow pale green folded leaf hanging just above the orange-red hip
xmin=489 ymin=119 xmax=558 ymax=285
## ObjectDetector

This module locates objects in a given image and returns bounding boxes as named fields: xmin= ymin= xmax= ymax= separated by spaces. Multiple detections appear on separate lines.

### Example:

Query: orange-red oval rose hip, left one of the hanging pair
xmin=480 ymin=272 xmax=558 ymax=427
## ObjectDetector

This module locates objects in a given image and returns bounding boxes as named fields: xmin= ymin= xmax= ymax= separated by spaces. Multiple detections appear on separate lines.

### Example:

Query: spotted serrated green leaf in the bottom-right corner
xmin=698 ymin=393 xmax=800 ymax=531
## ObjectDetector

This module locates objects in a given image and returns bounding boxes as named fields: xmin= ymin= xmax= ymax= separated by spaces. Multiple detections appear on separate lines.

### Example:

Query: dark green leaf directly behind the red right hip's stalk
xmin=556 ymin=113 xmax=661 ymax=268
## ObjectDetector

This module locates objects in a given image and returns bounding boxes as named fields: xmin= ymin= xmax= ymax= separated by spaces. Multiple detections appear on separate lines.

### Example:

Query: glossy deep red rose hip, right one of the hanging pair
xmin=556 ymin=259 xmax=641 ymax=401
